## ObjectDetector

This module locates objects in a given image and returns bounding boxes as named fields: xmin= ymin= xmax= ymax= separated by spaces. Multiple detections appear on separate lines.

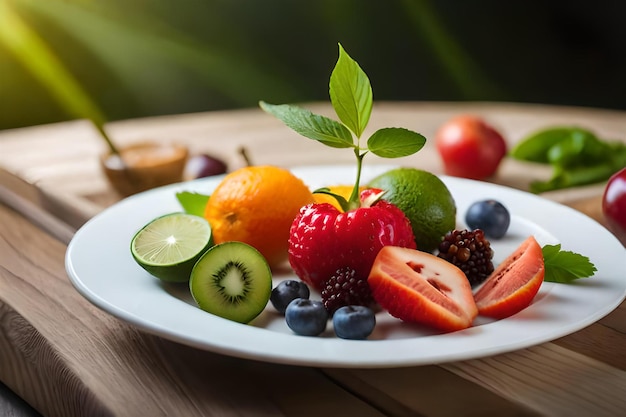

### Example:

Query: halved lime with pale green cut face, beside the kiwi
xmin=130 ymin=213 xmax=213 ymax=282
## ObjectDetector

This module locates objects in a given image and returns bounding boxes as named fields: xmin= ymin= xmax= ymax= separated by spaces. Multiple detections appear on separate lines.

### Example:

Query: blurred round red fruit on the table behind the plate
xmin=435 ymin=116 xmax=507 ymax=180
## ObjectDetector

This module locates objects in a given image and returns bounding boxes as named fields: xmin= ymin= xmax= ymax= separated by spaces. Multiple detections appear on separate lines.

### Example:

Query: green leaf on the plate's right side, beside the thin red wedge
xmin=541 ymin=244 xmax=597 ymax=283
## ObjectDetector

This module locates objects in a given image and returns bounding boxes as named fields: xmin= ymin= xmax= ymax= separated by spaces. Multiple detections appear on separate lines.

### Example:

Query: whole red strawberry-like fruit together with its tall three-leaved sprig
xmin=259 ymin=45 xmax=426 ymax=291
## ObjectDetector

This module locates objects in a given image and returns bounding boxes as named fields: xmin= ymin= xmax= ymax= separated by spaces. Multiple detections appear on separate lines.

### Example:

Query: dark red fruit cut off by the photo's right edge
xmin=602 ymin=168 xmax=626 ymax=246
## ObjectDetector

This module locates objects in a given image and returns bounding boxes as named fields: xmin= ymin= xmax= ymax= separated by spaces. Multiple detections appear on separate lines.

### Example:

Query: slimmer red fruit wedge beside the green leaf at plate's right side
xmin=474 ymin=236 xmax=545 ymax=319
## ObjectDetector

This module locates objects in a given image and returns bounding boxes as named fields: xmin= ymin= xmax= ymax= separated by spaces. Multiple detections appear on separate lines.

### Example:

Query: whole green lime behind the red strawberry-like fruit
xmin=368 ymin=168 xmax=456 ymax=252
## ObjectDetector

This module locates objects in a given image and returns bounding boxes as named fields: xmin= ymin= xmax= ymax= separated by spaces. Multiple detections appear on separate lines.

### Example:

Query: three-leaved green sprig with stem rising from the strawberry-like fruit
xmin=259 ymin=44 xmax=426 ymax=209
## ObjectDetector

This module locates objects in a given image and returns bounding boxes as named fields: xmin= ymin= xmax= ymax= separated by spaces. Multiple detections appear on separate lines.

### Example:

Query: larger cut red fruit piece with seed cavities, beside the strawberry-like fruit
xmin=367 ymin=246 xmax=478 ymax=331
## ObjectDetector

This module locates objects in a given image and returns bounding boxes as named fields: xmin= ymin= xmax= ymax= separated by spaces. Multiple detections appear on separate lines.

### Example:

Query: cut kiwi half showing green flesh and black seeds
xmin=189 ymin=241 xmax=272 ymax=323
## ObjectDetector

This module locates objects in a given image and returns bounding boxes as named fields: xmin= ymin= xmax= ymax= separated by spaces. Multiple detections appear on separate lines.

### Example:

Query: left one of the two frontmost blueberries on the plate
xmin=285 ymin=298 xmax=328 ymax=336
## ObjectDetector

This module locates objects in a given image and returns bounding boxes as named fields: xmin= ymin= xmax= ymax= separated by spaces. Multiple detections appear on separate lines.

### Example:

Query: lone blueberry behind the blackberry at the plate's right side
xmin=465 ymin=200 xmax=511 ymax=239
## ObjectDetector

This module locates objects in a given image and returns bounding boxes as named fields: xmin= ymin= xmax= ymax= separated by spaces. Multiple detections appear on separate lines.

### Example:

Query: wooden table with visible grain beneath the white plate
xmin=0 ymin=103 xmax=626 ymax=416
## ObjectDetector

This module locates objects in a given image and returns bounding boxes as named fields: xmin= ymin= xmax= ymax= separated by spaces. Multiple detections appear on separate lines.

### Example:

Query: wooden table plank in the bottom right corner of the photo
xmin=445 ymin=343 xmax=626 ymax=417
